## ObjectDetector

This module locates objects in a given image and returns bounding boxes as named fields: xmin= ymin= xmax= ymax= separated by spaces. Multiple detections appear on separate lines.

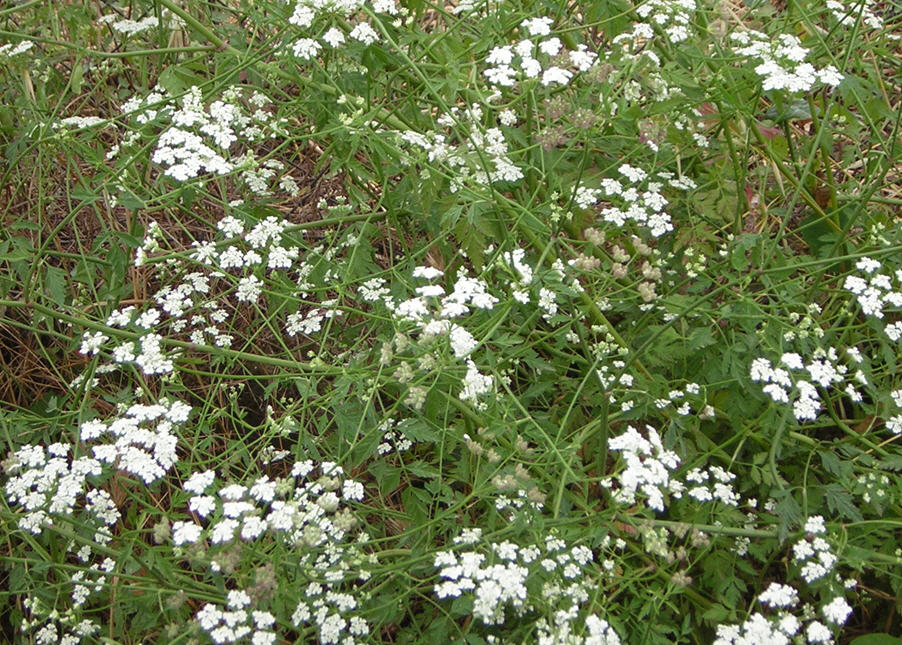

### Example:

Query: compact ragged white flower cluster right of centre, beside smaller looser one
xmin=601 ymin=426 xmax=685 ymax=513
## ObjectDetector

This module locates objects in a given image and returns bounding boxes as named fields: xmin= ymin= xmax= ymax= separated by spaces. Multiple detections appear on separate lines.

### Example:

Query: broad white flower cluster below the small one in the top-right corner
xmin=731 ymin=30 xmax=843 ymax=92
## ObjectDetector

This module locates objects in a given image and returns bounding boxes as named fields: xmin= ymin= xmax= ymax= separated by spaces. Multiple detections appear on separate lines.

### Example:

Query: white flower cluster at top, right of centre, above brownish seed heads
xmin=483 ymin=18 xmax=598 ymax=87
